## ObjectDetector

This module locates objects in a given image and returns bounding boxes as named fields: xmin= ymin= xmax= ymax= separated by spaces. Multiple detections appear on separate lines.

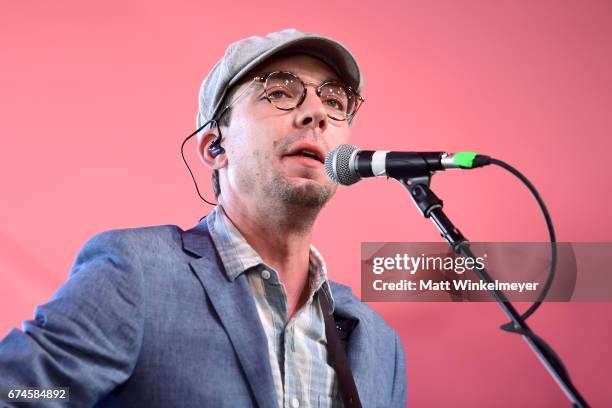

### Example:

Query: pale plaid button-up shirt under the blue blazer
xmin=206 ymin=205 xmax=343 ymax=408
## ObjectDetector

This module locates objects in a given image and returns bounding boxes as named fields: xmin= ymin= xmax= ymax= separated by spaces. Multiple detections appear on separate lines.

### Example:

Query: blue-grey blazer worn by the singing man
xmin=0 ymin=221 xmax=406 ymax=408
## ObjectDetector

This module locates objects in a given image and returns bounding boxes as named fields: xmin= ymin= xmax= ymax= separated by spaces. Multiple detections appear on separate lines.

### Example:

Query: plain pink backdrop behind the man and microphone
xmin=0 ymin=0 xmax=612 ymax=407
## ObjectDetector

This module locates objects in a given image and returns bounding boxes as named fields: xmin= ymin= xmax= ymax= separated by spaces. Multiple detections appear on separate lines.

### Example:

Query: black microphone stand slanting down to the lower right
xmin=399 ymin=173 xmax=589 ymax=408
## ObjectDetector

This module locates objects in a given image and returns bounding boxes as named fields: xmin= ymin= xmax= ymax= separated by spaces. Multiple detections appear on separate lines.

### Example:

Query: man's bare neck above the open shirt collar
xmin=219 ymin=196 xmax=318 ymax=318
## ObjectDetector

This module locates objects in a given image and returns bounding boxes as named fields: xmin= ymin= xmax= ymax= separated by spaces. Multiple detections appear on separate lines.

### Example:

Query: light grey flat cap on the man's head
xmin=196 ymin=28 xmax=363 ymax=128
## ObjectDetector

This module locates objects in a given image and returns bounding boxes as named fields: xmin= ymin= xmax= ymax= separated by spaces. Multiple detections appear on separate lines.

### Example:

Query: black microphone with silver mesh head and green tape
xmin=325 ymin=144 xmax=491 ymax=186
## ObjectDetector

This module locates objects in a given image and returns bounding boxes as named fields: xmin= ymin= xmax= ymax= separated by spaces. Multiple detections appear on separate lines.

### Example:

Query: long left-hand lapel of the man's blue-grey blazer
xmin=183 ymin=221 xmax=277 ymax=407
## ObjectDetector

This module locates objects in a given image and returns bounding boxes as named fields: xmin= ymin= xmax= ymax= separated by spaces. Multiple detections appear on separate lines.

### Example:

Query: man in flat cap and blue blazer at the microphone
xmin=0 ymin=30 xmax=405 ymax=408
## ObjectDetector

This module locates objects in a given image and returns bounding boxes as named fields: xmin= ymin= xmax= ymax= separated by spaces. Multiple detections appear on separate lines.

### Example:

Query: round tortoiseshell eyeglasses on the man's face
xmin=253 ymin=71 xmax=364 ymax=120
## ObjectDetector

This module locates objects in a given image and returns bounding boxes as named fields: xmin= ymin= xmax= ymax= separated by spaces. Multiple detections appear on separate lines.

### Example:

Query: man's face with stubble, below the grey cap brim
xmin=221 ymin=55 xmax=351 ymax=208
